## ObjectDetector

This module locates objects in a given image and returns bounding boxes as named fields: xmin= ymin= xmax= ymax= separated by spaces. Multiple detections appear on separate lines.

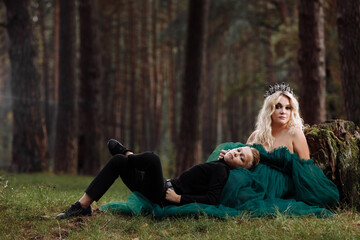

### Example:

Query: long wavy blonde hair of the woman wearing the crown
xmin=247 ymin=91 xmax=304 ymax=148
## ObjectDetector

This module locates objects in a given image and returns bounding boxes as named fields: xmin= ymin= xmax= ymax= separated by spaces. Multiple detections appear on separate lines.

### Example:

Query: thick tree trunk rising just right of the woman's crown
xmin=299 ymin=0 xmax=326 ymax=124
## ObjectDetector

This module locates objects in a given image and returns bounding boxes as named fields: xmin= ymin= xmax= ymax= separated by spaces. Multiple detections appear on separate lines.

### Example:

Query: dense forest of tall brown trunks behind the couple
xmin=0 ymin=0 xmax=360 ymax=176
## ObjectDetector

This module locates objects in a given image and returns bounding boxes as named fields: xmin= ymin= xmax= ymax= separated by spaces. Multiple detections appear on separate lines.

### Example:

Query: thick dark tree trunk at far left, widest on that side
xmin=4 ymin=0 xmax=47 ymax=172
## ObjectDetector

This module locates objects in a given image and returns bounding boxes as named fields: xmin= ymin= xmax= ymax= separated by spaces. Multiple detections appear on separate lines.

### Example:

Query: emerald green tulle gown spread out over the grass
xmin=100 ymin=142 xmax=339 ymax=218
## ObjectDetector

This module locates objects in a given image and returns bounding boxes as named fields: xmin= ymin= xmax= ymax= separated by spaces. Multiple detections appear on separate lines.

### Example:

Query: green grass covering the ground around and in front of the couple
xmin=0 ymin=173 xmax=360 ymax=239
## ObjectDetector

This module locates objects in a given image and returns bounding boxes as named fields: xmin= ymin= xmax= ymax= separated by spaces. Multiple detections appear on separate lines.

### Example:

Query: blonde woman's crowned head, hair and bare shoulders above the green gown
xmin=247 ymin=83 xmax=310 ymax=159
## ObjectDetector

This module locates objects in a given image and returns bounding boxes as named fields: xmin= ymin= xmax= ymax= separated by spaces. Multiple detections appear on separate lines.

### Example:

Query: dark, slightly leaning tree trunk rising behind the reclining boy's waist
xmin=176 ymin=0 xmax=209 ymax=175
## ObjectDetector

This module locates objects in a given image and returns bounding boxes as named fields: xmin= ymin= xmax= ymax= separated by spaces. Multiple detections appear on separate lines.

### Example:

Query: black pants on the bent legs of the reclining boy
xmin=85 ymin=152 xmax=164 ymax=204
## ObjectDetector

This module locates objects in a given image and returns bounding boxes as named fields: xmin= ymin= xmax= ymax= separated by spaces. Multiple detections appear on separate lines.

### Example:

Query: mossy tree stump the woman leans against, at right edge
xmin=304 ymin=120 xmax=360 ymax=209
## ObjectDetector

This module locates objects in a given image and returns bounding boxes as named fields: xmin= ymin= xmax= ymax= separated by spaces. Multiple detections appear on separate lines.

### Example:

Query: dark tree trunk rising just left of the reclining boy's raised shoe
xmin=78 ymin=0 xmax=102 ymax=174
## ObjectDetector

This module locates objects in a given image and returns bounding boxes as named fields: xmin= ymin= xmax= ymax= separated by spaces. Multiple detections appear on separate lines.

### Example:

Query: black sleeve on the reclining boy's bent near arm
xmin=180 ymin=167 xmax=229 ymax=205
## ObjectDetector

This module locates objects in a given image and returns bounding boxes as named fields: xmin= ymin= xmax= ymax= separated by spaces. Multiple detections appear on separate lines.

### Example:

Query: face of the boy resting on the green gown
xmin=224 ymin=147 xmax=253 ymax=168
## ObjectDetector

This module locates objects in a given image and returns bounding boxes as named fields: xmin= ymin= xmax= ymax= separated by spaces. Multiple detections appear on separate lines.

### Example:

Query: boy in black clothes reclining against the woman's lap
xmin=57 ymin=139 xmax=260 ymax=219
